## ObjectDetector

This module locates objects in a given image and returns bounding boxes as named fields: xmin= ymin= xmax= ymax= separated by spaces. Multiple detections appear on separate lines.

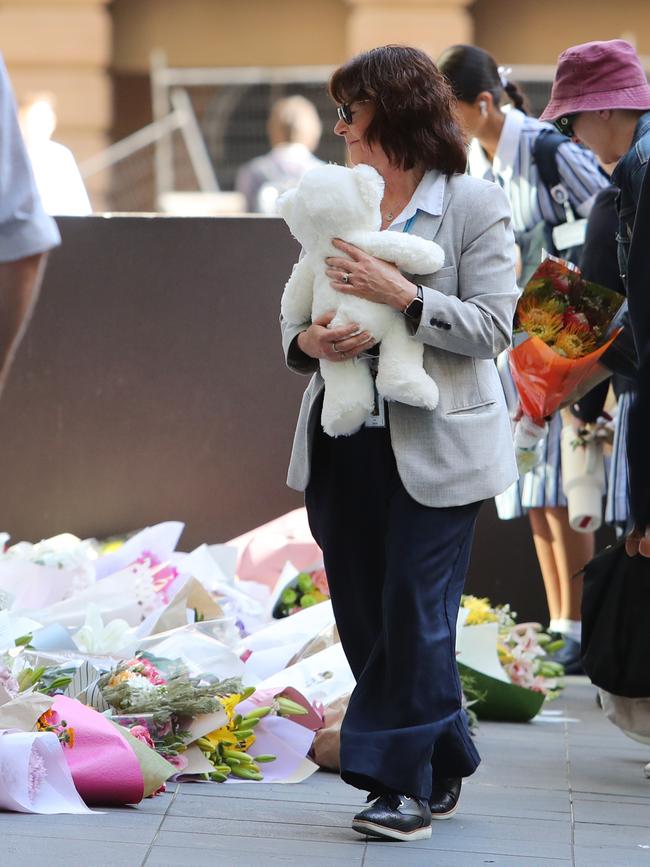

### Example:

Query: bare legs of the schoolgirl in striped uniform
xmin=528 ymin=506 xmax=594 ymax=620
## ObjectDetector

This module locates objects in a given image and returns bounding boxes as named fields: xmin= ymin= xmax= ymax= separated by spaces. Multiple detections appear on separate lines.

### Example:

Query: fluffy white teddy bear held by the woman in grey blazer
xmin=278 ymin=165 xmax=444 ymax=437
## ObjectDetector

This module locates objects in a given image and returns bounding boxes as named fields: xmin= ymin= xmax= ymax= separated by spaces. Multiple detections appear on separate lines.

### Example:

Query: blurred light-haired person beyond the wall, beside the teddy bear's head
xmin=235 ymin=96 xmax=322 ymax=214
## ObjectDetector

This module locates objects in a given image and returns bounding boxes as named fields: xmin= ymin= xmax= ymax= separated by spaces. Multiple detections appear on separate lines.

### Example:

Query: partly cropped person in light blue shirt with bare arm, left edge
xmin=0 ymin=56 xmax=61 ymax=400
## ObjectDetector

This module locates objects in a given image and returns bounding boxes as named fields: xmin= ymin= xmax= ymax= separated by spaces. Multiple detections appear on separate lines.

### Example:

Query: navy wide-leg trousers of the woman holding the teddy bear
xmin=305 ymin=418 xmax=481 ymax=798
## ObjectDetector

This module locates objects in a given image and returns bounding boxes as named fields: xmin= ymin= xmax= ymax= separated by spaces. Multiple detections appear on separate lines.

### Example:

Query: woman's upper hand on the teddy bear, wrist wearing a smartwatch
xmin=325 ymin=238 xmax=417 ymax=310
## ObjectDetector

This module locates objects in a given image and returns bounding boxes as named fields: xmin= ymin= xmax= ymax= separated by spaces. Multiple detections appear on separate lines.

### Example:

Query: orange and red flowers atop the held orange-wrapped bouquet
xmin=515 ymin=256 xmax=623 ymax=358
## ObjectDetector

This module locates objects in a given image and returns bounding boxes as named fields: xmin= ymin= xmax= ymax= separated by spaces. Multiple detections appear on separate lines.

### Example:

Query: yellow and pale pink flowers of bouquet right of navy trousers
xmin=461 ymin=596 xmax=564 ymax=699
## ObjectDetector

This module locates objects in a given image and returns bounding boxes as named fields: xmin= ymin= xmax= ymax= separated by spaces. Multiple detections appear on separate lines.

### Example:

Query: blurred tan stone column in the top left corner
xmin=0 ymin=0 xmax=112 ymax=209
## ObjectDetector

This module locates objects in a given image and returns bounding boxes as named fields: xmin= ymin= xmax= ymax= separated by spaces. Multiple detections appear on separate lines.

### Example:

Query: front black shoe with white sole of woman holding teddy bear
xmin=352 ymin=794 xmax=431 ymax=840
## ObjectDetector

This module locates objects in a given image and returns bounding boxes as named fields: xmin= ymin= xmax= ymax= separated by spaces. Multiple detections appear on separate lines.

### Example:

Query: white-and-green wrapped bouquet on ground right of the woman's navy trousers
xmin=459 ymin=596 xmax=564 ymax=720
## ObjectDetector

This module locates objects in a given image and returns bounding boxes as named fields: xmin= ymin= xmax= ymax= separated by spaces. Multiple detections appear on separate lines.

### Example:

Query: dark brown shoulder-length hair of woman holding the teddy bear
xmin=329 ymin=45 xmax=467 ymax=175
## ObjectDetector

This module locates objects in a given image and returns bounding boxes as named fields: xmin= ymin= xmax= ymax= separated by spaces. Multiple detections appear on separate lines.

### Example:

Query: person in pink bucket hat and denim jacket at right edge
xmin=542 ymin=39 xmax=650 ymax=556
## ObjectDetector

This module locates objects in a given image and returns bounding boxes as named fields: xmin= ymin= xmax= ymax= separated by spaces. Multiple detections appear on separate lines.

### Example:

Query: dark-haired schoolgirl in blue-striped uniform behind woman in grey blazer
xmin=439 ymin=45 xmax=608 ymax=674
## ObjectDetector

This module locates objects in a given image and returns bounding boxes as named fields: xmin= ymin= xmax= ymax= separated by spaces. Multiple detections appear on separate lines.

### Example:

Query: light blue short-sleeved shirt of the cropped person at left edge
xmin=0 ymin=55 xmax=61 ymax=262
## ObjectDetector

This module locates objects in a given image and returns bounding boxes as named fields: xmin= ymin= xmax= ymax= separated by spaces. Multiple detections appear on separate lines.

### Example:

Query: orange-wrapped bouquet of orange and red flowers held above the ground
xmin=509 ymin=256 xmax=623 ymax=472
